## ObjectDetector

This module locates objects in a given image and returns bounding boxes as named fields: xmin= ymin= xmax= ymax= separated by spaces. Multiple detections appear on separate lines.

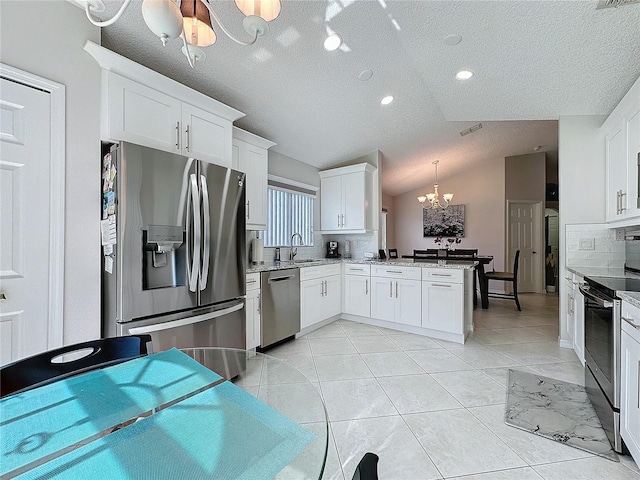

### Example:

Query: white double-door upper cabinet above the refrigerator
xmin=85 ymin=42 xmax=243 ymax=167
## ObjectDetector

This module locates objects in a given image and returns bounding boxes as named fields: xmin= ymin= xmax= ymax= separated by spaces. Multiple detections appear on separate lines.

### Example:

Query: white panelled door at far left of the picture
xmin=0 ymin=78 xmax=52 ymax=364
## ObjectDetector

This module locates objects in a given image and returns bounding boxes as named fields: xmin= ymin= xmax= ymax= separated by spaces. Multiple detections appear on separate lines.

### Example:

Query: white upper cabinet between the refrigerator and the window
xmin=232 ymin=127 xmax=275 ymax=230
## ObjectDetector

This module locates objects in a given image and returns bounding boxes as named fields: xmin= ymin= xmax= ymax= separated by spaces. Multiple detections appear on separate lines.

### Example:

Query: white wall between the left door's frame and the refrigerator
xmin=0 ymin=0 xmax=101 ymax=344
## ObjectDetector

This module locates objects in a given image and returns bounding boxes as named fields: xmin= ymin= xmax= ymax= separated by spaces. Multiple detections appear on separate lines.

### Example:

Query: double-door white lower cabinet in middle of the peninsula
xmin=371 ymin=265 xmax=421 ymax=326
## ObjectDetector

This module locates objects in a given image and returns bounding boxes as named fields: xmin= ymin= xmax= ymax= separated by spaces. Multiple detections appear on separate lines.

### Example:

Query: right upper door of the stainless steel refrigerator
xmin=200 ymin=162 xmax=247 ymax=305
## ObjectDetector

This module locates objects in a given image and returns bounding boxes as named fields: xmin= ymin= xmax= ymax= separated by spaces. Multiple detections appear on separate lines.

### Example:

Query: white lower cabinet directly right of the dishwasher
xmin=300 ymin=263 xmax=342 ymax=330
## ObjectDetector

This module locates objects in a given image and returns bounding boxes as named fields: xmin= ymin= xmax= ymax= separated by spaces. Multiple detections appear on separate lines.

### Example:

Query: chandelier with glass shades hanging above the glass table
xmin=69 ymin=0 xmax=281 ymax=68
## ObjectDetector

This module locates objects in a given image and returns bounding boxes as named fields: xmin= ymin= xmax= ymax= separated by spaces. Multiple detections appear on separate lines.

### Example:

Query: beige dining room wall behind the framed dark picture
xmin=390 ymin=158 xmax=505 ymax=270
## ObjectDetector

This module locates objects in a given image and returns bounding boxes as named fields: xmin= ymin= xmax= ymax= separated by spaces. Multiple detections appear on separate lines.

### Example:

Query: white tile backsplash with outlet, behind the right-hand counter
xmin=565 ymin=224 xmax=625 ymax=268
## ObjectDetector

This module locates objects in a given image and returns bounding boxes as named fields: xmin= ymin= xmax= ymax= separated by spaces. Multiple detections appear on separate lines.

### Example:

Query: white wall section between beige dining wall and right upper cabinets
xmin=558 ymin=115 xmax=606 ymax=347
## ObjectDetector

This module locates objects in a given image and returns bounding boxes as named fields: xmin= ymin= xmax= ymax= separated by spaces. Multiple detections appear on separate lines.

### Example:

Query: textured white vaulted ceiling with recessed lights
xmin=94 ymin=0 xmax=640 ymax=195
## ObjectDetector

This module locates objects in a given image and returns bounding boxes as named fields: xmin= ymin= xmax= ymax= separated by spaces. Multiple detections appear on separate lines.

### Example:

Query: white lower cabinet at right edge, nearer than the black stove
xmin=620 ymin=302 xmax=640 ymax=464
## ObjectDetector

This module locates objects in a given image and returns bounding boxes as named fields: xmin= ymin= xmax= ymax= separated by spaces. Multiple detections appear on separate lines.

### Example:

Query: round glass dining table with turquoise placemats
xmin=0 ymin=347 xmax=328 ymax=480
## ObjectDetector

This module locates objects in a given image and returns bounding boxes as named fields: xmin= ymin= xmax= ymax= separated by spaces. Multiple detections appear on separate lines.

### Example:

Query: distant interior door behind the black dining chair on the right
xmin=505 ymin=202 xmax=544 ymax=293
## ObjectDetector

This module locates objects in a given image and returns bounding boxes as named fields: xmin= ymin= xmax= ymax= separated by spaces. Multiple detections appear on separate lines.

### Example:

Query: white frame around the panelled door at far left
xmin=0 ymin=63 xmax=66 ymax=349
